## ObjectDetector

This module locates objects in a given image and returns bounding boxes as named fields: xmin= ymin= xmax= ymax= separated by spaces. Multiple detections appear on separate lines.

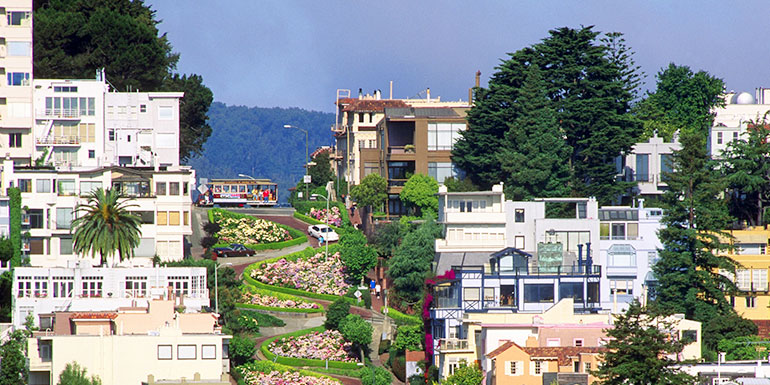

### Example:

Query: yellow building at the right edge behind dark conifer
xmin=728 ymin=226 xmax=770 ymax=336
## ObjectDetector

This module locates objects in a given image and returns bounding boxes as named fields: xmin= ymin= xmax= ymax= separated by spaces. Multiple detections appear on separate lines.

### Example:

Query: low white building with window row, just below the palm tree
xmin=11 ymin=268 xmax=209 ymax=330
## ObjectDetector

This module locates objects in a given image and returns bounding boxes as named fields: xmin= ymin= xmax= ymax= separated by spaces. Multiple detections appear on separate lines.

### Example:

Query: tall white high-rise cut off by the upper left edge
xmin=0 ymin=0 xmax=34 ymax=164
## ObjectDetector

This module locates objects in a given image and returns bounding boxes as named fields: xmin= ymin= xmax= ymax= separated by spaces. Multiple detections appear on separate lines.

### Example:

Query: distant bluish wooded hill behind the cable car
xmin=187 ymin=102 xmax=334 ymax=202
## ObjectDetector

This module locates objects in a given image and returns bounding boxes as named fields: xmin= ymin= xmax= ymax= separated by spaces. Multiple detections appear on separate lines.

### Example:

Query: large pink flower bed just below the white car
xmin=251 ymin=253 xmax=350 ymax=295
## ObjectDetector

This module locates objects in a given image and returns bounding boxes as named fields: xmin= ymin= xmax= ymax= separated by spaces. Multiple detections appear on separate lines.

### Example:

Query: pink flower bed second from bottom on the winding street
xmin=267 ymin=330 xmax=356 ymax=362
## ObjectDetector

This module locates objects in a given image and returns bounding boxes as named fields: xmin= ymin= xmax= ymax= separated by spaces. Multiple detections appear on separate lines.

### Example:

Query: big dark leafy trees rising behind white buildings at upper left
xmin=33 ymin=0 xmax=213 ymax=160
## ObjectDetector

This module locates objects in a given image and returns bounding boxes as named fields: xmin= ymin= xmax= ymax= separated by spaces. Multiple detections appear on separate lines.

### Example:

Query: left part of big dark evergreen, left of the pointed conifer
xmin=452 ymin=48 xmax=536 ymax=189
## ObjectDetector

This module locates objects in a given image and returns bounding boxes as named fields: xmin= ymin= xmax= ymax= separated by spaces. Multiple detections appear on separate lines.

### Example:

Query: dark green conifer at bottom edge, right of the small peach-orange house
xmin=592 ymin=300 xmax=695 ymax=385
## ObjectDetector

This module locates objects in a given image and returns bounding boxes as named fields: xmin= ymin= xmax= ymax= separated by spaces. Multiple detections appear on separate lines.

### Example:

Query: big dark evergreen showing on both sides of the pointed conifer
xmin=452 ymin=27 xmax=642 ymax=203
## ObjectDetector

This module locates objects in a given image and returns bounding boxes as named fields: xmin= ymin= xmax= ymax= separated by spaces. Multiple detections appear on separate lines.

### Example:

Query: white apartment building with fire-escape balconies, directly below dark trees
xmin=34 ymin=75 xmax=183 ymax=169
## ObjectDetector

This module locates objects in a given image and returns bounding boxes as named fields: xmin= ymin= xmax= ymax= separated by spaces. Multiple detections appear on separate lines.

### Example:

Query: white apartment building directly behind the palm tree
xmin=0 ymin=156 xmax=195 ymax=267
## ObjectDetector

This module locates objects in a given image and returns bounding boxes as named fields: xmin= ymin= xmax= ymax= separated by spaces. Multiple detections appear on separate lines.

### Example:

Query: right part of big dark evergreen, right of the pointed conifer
xmin=536 ymin=27 xmax=642 ymax=204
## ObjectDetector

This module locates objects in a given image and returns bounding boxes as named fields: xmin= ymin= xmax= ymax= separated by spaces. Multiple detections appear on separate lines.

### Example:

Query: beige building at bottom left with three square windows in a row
xmin=28 ymin=301 xmax=231 ymax=385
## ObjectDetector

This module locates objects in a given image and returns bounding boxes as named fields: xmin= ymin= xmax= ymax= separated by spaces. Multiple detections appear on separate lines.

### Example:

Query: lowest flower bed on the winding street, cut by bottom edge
xmin=235 ymin=361 xmax=340 ymax=385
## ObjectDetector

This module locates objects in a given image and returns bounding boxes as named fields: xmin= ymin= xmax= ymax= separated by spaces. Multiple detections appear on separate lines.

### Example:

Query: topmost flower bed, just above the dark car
xmin=213 ymin=211 xmax=292 ymax=245
